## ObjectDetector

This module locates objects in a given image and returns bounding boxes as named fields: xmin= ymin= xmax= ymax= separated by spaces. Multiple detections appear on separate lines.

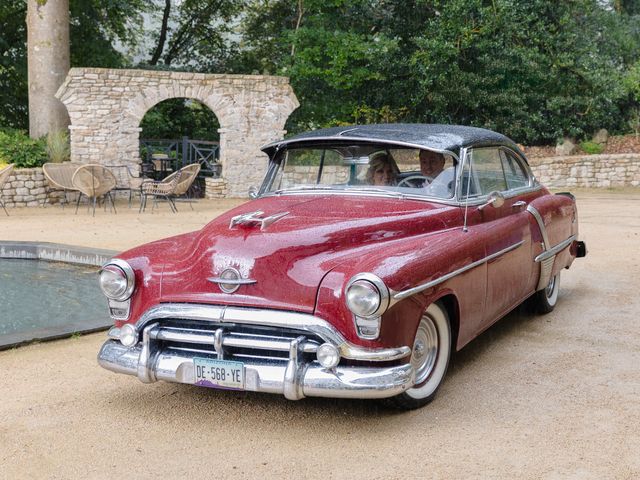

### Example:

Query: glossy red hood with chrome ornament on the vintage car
xmin=161 ymin=195 xmax=453 ymax=312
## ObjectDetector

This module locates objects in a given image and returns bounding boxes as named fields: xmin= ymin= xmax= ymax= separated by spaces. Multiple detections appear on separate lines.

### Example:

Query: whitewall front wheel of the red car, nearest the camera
xmin=386 ymin=302 xmax=451 ymax=410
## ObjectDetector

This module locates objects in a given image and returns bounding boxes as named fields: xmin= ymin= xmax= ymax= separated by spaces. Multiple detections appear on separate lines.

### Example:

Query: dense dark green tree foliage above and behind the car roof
xmin=235 ymin=0 xmax=640 ymax=144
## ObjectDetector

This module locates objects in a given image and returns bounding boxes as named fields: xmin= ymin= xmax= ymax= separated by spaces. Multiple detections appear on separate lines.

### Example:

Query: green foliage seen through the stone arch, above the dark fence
xmin=140 ymin=98 xmax=220 ymax=141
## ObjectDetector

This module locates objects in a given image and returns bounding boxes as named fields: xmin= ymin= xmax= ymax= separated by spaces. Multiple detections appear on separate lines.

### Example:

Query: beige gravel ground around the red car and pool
xmin=0 ymin=190 xmax=640 ymax=480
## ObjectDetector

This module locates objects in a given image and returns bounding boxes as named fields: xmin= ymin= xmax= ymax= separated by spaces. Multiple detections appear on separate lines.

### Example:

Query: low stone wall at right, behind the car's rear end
xmin=529 ymin=153 xmax=640 ymax=188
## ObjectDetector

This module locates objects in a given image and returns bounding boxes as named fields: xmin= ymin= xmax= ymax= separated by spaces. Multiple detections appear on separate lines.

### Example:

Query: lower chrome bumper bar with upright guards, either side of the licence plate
xmin=98 ymin=340 xmax=414 ymax=400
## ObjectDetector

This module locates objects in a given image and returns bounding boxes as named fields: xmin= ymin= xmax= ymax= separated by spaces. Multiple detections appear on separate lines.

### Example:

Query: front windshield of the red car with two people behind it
xmin=263 ymin=145 xmax=456 ymax=198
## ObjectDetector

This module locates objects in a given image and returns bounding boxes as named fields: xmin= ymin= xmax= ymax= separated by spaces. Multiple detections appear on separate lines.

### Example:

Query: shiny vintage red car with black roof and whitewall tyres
xmin=98 ymin=124 xmax=586 ymax=408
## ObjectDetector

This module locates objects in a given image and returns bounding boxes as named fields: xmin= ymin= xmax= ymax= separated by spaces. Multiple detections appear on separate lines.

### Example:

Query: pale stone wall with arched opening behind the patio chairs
xmin=56 ymin=68 xmax=299 ymax=197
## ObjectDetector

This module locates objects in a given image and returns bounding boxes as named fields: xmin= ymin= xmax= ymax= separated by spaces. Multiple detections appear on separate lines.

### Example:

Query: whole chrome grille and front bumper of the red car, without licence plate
xmin=98 ymin=303 xmax=415 ymax=400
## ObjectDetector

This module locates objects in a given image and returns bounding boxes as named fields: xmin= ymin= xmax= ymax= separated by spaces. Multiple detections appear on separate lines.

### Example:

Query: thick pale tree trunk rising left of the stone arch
xmin=27 ymin=0 xmax=70 ymax=138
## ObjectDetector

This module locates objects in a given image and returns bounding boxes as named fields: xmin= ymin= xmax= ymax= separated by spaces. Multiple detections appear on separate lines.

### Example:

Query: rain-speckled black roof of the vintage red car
xmin=262 ymin=123 xmax=522 ymax=157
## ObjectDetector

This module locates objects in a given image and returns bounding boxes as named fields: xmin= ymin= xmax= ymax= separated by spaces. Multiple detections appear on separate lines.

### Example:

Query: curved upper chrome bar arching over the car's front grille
xmin=136 ymin=303 xmax=411 ymax=362
